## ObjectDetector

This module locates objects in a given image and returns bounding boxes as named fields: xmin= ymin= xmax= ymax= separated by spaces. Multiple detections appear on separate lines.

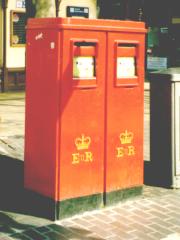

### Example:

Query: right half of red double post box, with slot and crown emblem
xmin=105 ymin=22 xmax=145 ymax=203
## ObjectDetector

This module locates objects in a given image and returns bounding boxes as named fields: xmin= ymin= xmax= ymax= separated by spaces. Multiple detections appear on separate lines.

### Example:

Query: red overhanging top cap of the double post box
xmin=27 ymin=18 xmax=146 ymax=33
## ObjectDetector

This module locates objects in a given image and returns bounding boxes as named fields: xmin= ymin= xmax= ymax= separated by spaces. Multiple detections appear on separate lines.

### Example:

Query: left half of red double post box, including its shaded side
xmin=25 ymin=19 xmax=106 ymax=218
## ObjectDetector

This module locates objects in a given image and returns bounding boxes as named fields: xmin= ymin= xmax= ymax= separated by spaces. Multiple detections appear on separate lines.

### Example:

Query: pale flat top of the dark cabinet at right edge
xmin=149 ymin=67 xmax=180 ymax=82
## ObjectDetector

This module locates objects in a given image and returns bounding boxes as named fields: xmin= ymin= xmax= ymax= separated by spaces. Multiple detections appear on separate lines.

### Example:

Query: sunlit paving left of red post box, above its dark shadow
xmin=0 ymin=92 xmax=25 ymax=160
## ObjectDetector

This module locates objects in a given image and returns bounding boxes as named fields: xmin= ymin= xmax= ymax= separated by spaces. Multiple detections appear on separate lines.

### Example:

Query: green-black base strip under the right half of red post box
xmin=105 ymin=186 xmax=143 ymax=206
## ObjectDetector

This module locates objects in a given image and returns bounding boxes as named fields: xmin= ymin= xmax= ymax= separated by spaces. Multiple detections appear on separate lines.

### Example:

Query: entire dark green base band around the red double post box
xmin=25 ymin=186 xmax=143 ymax=221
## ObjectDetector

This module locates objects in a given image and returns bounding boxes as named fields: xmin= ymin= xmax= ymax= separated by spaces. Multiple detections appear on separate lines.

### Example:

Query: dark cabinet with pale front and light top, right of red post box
xmin=149 ymin=67 xmax=180 ymax=188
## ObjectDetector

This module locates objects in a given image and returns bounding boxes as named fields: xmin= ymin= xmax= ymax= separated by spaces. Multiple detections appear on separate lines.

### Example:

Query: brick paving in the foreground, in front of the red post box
xmin=0 ymin=186 xmax=180 ymax=240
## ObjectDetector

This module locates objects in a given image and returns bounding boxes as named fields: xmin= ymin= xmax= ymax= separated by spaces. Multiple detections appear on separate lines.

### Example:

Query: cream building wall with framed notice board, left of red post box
xmin=0 ymin=0 xmax=26 ymax=91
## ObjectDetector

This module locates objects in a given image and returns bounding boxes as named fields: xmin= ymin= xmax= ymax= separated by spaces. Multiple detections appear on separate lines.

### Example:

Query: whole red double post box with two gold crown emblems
xmin=25 ymin=18 xmax=146 ymax=219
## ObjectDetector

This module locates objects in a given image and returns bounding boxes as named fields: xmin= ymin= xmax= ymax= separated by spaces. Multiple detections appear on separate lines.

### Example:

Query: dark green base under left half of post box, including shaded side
xmin=26 ymin=190 xmax=103 ymax=221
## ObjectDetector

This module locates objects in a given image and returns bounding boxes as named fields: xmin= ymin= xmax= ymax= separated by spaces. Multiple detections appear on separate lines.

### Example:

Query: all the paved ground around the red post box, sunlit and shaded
xmin=0 ymin=91 xmax=180 ymax=240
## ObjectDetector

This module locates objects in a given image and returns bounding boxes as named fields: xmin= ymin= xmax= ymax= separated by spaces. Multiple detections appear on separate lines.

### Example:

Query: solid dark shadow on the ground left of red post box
xmin=0 ymin=155 xmax=53 ymax=219
